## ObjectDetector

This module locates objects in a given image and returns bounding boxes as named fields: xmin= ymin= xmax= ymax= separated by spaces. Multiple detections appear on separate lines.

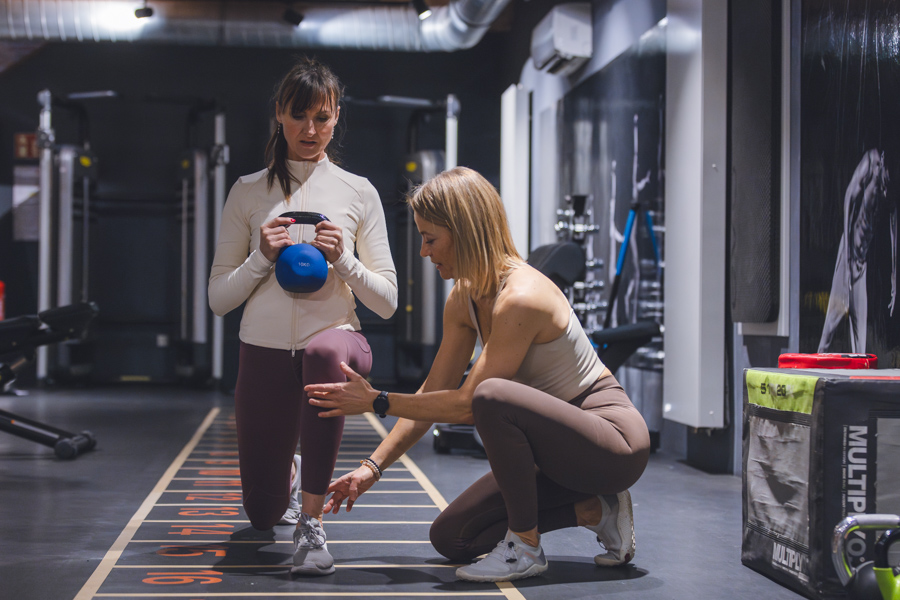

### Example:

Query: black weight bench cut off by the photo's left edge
xmin=0 ymin=302 xmax=97 ymax=459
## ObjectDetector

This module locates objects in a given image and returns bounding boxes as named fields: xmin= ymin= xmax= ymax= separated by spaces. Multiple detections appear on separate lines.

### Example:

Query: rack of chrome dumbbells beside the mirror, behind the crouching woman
xmin=554 ymin=194 xmax=607 ymax=335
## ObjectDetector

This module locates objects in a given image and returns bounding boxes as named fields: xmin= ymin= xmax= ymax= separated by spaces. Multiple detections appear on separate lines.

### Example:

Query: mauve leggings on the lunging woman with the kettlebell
xmin=234 ymin=329 xmax=372 ymax=530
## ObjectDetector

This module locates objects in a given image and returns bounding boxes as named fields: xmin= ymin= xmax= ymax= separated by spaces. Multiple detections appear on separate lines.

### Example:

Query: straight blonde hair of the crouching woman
xmin=407 ymin=167 xmax=525 ymax=298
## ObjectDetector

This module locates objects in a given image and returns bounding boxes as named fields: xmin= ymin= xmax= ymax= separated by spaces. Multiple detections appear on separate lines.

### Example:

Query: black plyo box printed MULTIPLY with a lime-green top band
xmin=741 ymin=369 xmax=900 ymax=600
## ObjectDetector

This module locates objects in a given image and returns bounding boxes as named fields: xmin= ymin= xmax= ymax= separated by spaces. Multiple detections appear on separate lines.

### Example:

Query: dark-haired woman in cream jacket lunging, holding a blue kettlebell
xmin=209 ymin=58 xmax=397 ymax=575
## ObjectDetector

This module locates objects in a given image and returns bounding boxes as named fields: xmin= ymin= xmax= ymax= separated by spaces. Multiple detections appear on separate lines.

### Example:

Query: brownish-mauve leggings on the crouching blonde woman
xmin=431 ymin=375 xmax=650 ymax=561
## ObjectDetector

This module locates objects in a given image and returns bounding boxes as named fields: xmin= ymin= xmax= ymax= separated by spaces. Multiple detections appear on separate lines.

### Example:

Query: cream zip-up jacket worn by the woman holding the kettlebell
xmin=209 ymin=158 xmax=397 ymax=351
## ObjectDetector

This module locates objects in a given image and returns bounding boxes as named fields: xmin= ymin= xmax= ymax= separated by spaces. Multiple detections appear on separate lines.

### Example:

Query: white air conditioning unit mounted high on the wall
xmin=531 ymin=2 xmax=593 ymax=75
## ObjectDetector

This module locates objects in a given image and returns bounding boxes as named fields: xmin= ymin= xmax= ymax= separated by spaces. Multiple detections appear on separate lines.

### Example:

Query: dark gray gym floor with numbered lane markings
xmin=0 ymin=387 xmax=802 ymax=600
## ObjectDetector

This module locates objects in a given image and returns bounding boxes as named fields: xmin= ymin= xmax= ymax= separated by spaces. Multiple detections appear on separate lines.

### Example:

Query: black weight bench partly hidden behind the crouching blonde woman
xmin=432 ymin=242 xmax=660 ymax=454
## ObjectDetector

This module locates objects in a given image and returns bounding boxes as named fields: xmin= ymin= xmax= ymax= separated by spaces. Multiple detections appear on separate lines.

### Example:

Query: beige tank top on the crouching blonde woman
xmin=469 ymin=298 xmax=605 ymax=402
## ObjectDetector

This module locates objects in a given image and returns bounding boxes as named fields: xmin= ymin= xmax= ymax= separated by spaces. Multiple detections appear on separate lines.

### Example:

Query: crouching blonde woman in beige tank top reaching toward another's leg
xmin=306 ymin=167 xmax=650 ymax=581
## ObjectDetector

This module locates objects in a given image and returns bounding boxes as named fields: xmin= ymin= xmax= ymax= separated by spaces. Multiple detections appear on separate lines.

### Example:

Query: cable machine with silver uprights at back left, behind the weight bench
xmin=36 ymin=90 xmax=229 ymax=383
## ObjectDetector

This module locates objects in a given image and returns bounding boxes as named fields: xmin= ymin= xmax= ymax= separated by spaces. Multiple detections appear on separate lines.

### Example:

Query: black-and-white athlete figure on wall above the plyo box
xmin=818 ymin=148 xmax=897 ymax=354
